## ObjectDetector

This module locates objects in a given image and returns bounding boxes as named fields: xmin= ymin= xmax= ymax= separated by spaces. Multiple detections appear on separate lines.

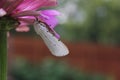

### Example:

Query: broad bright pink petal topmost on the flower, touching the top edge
xmin=16 ymin=0 xmax=56 ymax=11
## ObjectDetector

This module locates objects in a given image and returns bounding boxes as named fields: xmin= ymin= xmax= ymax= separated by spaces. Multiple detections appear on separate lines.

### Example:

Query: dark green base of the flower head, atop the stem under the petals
xmin=0 ymin=15 xmax=19 ymax=31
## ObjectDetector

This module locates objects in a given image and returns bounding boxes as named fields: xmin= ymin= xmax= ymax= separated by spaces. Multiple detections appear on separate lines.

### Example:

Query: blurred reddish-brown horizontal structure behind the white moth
xmin=9 ymin=37 xmax=120 ymax=80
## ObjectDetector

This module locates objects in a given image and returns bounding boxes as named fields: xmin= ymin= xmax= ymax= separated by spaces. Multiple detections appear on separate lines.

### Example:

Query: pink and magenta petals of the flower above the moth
xmin=0 ymin=0 xmax=60 ymax=37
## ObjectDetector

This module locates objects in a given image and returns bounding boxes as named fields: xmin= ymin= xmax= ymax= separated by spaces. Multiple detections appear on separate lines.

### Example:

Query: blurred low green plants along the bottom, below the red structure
xmin=11 ymin=59 xmax=112 ymax=80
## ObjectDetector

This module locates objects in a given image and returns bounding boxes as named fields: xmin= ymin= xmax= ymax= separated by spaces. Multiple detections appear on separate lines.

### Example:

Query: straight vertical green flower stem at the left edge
xmin=0 ymin=31 xmax=7 ymax=80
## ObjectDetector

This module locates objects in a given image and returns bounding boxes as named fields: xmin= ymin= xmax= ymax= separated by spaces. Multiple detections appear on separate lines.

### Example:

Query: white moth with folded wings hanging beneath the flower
xmin=34 ymin=21 xmax=69 ymax=57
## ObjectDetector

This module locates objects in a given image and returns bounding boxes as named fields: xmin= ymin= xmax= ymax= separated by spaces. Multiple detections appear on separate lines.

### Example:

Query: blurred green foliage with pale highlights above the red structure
xmin=11 ymin=0 xmax=120 ymax=45
